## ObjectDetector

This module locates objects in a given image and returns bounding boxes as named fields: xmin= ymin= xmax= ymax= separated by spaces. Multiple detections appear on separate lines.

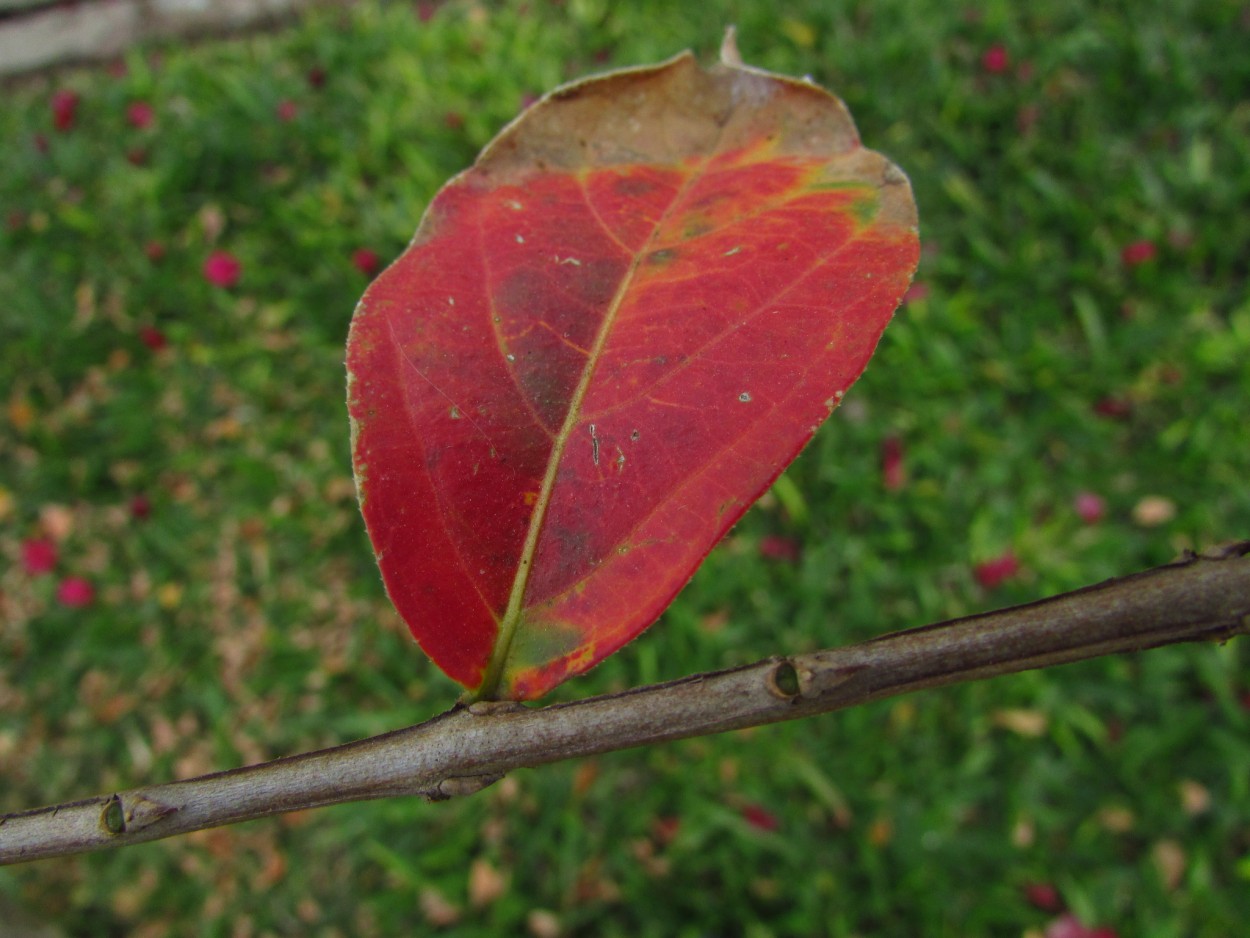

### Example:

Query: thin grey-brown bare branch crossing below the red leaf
xmin=0 ymin=542 xmax=1250 ymax=864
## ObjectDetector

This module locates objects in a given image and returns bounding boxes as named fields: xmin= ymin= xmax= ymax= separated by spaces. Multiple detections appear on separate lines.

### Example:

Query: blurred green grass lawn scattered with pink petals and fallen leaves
xmin=0 ymin=0 xmax=1250 ymax=938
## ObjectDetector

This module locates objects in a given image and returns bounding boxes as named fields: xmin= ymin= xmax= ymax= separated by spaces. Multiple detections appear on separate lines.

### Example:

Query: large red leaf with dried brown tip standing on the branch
xmin=348 ymin=53 xmax=919 ymax=699
